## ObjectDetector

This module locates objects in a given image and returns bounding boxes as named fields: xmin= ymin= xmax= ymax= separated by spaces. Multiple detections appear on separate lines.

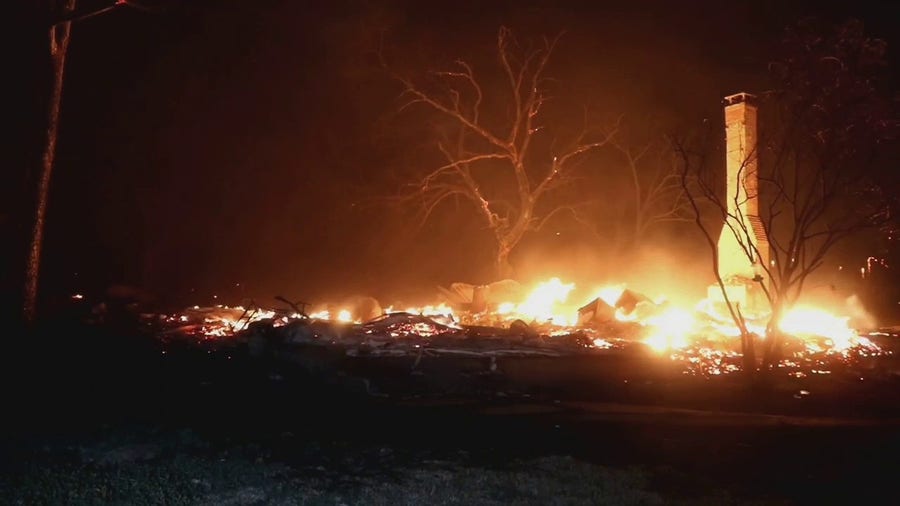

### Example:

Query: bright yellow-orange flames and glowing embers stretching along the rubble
xmin=167 ymin=277 xmax=882 ymax=376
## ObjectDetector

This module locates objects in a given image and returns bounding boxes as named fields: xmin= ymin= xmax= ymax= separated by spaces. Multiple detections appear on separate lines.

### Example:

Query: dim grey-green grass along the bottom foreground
xmin=0 ymin=431 xmax=786 ymax=506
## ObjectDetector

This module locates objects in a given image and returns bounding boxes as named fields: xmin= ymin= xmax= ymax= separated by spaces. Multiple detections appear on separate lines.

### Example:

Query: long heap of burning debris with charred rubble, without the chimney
xmin=155 ymin=278 xmax=889 ymax=377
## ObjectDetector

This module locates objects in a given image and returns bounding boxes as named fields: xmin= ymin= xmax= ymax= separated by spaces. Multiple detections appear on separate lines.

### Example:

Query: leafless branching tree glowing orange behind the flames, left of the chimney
xmin=391 ymin=27 xmax=616 ymax=277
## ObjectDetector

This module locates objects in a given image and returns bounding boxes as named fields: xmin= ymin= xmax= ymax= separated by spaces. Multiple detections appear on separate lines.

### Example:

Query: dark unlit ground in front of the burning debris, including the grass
xmin=0 ymin=318 xmax=900 ymax=505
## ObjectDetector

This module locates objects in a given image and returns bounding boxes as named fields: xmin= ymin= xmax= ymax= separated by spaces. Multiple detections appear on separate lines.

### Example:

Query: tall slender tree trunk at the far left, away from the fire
xmin=22 ymin=0 xmax=75 ymax=323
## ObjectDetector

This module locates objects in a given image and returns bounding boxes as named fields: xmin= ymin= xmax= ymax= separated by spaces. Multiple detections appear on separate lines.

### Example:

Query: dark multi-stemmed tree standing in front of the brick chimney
xmin=677 ymin=17 xmax=897 ymax=371
